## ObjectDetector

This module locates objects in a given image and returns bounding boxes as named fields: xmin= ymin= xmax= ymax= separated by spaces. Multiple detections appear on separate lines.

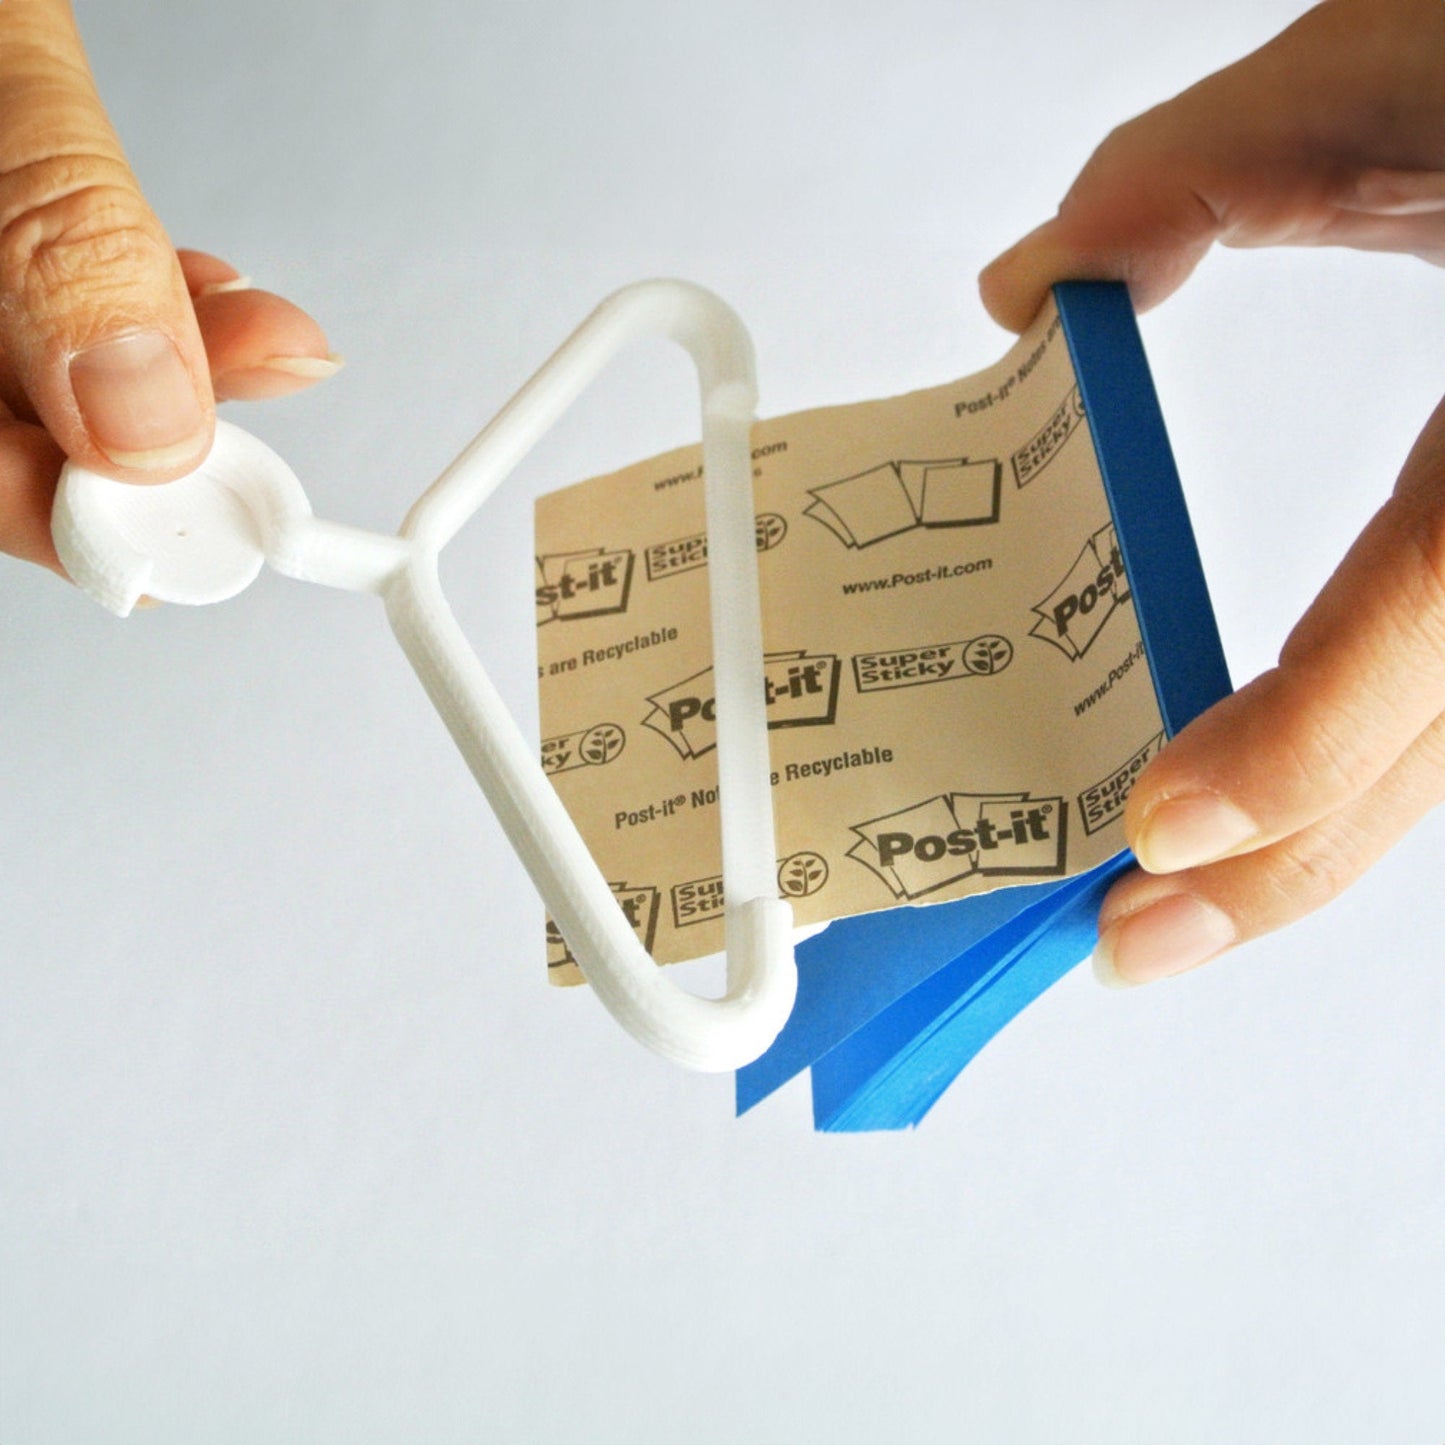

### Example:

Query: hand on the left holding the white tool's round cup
xmin=0 ymin=0 xmax=340 ymax=572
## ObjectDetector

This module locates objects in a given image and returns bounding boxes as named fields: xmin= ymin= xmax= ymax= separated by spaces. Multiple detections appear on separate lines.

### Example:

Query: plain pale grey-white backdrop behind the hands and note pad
xmin=0 ymin=0 xmax=1445 ymax=1445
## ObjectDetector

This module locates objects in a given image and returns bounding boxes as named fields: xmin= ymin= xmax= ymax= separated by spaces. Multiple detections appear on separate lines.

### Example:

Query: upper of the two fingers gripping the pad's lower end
xmin=1124 ymin=390 xmax=1445 ymax=873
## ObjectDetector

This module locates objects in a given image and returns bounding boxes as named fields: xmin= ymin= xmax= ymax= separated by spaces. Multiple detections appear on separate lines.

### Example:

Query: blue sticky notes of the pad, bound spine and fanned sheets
xmin=737 ymin=282 xmax=1230 ymax=1131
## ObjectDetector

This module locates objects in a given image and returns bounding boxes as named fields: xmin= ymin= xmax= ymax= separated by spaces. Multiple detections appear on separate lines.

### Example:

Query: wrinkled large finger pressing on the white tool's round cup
xmin=0 ymin=0 xmax=215 ymax=481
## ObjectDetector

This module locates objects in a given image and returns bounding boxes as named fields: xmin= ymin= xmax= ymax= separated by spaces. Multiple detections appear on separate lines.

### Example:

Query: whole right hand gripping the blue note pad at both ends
xmin=980 ymin=0 xmax=1445 ymax=984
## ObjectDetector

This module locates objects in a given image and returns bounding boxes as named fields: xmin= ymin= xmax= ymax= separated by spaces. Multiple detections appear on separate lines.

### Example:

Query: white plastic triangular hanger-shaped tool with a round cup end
xmin=52 ymin=280 xmax=798 ymax=1069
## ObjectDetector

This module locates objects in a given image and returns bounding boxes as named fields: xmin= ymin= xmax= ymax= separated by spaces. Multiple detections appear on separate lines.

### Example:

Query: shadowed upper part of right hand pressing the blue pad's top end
xmin=978 ymin=0 xmax=1445 ymax=331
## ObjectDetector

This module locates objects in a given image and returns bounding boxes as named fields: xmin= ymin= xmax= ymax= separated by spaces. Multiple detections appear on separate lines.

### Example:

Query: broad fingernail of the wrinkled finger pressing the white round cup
xmin=71 ymin=331 xmax=205 ymax=468
